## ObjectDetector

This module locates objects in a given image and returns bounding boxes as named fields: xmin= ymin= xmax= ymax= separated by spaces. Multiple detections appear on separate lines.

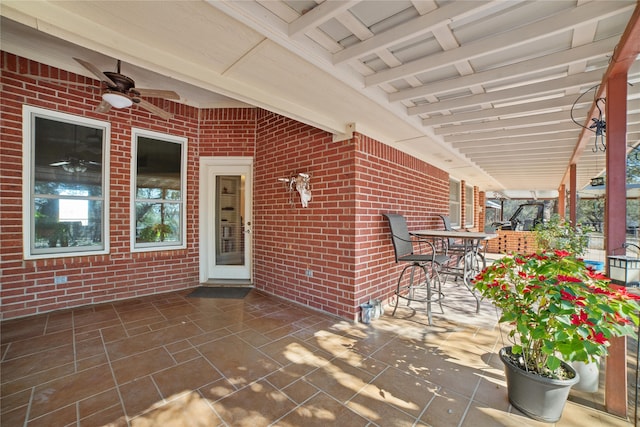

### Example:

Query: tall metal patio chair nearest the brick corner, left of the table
xmin=383 ymin=213 xmax=449 ymax=325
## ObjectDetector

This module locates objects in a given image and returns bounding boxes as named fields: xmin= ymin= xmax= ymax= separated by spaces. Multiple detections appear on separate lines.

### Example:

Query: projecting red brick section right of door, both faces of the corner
xmin=253 ymin=120 xmax=449 ymax=319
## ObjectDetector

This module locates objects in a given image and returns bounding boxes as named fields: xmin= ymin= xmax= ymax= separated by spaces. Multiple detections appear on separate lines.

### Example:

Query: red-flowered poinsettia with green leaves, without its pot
xmin=475 ymin=250 xmax=640 ymax=377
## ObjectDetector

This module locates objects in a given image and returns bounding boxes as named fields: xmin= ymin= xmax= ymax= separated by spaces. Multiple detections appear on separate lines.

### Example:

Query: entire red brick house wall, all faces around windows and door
xmin=0 ymin=52 xmax=456 ymax=319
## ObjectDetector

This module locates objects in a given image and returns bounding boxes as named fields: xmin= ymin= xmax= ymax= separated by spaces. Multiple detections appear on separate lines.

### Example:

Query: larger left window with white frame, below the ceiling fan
xmin=22 ymin=105 xmax=110 ymax=259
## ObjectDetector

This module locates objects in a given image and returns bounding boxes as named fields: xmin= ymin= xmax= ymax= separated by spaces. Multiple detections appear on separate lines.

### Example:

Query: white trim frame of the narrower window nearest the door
xmin=130 ymin=128 xmax=188 ymax=252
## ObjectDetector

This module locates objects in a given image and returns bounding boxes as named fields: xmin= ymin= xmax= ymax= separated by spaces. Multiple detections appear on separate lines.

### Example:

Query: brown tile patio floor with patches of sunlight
xmin=0 ymin=284 xmax=633 ymax=427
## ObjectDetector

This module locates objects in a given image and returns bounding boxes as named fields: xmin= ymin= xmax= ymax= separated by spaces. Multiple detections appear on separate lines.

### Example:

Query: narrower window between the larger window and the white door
xmin=131 ymin=129 xmax=187 ymax=251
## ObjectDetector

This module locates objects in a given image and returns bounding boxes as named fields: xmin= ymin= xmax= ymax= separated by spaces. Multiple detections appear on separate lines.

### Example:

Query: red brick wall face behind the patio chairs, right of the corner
xmin=354 ymin=134 xmax=449 ymax=320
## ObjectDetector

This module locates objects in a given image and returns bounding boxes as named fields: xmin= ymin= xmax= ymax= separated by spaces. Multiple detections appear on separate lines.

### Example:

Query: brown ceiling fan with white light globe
xmin=73 ymin=58 xmax=180 ymax=119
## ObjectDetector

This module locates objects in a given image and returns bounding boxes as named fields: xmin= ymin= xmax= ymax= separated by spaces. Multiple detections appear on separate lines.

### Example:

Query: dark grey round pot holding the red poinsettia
xmin=500 ymin=347 xmax=580 ymax=423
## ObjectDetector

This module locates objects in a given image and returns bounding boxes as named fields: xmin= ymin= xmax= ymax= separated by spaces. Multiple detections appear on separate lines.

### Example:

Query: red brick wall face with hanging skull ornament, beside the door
xmin=253 ymin=111 xmax=357 ymax=317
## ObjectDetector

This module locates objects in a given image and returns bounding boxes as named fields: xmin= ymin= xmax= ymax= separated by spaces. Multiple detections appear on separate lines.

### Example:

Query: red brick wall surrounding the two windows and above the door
xmin=0 ymin=52 xmax=255 ymax=318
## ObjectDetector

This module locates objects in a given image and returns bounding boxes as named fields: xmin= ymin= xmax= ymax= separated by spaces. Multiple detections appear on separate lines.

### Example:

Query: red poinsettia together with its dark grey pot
xmin=475 ymin=250 xmax=640 ymax=422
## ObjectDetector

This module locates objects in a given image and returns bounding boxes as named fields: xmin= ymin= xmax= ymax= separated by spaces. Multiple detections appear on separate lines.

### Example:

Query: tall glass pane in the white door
xmin=216 ymin=175 xmax=245 ymax=265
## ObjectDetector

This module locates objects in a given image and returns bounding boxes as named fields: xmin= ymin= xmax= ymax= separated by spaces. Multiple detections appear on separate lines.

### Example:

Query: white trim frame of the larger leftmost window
xmin=22 ymin=105 xmax=111 ymax=260
